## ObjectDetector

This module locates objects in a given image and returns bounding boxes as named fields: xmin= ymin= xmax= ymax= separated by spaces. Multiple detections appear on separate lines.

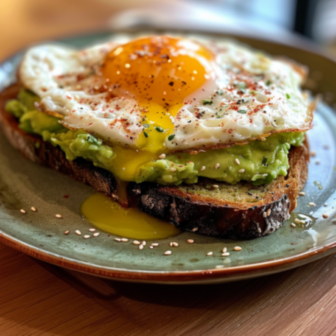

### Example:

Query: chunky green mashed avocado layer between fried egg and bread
xmin=6 ymin=90 xmax=304 ymax=185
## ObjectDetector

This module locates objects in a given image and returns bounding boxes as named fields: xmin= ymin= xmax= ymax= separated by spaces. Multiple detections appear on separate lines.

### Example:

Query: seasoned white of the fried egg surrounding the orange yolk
xmin=19 ymin=37 xmax=312 ymax=151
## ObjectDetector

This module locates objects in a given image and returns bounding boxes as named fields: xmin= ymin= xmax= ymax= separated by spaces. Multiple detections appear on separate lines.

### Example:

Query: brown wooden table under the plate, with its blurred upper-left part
xmin=0 ymin=0 xmax=336 ymax=336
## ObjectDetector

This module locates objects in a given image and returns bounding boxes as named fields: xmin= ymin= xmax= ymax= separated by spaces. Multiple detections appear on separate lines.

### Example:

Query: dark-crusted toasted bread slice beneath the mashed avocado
xmin=0 ymin=85 xmax=309 ymax=239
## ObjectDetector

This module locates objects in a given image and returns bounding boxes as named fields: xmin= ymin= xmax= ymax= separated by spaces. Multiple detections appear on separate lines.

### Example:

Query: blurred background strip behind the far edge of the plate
xmin=0 ymin=0 xmax=336 ymax=59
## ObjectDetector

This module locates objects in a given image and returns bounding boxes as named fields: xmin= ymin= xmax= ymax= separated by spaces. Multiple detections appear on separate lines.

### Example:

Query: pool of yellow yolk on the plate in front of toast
xmin=82 ymin=193 xmax=181 ymax=239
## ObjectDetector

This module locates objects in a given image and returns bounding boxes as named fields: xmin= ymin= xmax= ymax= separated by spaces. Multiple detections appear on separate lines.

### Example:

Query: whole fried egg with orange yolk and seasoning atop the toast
xmin=19 ymin=36 xmax=312 ymax=169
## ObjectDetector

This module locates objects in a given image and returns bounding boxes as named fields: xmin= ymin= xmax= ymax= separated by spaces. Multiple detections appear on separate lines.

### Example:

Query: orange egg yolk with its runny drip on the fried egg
xmin=102 ymin=36 xmax=214 ymax=181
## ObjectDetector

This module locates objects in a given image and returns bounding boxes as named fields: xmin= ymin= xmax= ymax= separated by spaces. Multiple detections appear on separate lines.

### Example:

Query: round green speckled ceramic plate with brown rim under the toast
xmin=0 ymin=33 xmax=336 ymax=284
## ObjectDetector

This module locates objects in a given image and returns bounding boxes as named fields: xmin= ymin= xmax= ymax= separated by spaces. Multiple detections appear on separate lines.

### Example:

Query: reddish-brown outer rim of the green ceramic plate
xmin=0 ymin=28 xmax=336 ymax=284
